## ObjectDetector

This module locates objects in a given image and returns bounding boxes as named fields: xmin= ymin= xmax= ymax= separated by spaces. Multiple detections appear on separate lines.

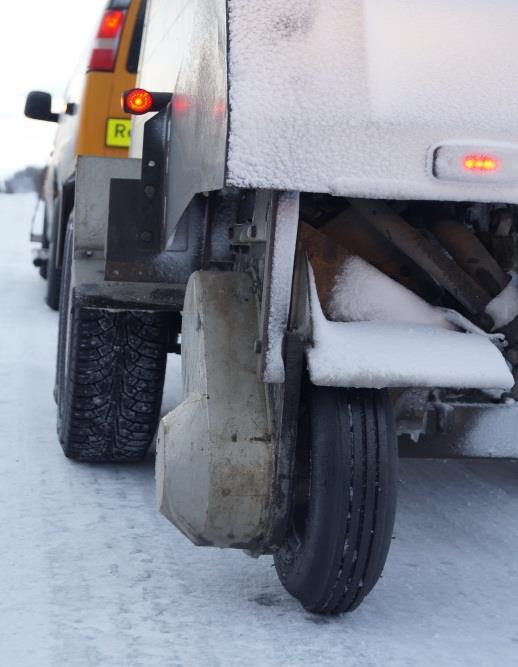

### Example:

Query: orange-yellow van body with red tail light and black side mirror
xmin=25 ymin=0 xmax=146 ymax=310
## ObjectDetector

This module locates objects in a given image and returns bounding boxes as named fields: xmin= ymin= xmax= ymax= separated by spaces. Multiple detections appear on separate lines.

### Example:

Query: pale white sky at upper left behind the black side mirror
xmin=0 ymin=0 xmax=107 ymax=178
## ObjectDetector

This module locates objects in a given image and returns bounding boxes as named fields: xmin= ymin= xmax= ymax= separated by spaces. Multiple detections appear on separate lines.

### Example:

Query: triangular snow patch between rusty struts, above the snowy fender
xmin=329 ymin=255 xmax=455 ymax=330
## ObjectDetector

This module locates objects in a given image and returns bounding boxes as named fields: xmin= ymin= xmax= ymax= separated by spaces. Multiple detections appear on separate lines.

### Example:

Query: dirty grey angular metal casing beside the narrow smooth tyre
xmin=156 ymin=271 xmax=274 ymax=550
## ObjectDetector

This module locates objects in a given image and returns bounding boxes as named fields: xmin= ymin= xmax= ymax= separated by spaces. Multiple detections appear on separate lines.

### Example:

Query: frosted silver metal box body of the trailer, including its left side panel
xmin=133 ymin=0 xmax=518 ymax=240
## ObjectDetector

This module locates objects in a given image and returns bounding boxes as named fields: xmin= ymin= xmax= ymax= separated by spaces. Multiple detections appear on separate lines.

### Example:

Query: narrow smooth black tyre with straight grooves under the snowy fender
xmin=274 ymin=384 xmax=397 ymax=614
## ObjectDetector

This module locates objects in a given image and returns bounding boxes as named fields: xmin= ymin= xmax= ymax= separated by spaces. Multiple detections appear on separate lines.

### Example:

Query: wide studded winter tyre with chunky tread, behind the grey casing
xmin=55 ymin=226 xmax=168 ymax=462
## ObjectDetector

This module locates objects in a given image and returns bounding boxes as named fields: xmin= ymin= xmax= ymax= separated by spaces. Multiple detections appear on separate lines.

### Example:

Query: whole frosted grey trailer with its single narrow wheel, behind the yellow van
xmin=61 ymin=0 xmax=518 ymax=614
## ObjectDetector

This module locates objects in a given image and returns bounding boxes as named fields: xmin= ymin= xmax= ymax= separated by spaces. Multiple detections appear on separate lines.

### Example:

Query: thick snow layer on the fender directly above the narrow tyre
xmin=307 ymin=273 xmax=514 ymax=389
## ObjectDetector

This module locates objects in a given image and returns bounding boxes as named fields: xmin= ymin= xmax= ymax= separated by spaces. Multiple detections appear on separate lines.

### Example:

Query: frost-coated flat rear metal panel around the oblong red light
xmin=228 ymin=0 xmax=518 ymax=203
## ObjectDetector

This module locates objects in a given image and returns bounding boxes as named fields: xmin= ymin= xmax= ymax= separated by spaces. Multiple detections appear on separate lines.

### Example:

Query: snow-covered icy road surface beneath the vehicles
xmin=0 ymin=195 xmax=518 ymax=667
